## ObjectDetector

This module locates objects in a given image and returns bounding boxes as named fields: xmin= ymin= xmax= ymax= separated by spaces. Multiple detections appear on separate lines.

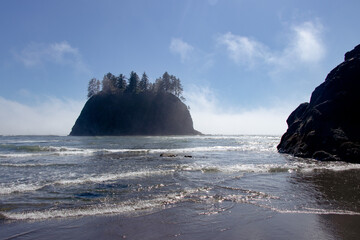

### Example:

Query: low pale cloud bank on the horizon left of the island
xmin=0 ymin=97 xmax=84 ymax=135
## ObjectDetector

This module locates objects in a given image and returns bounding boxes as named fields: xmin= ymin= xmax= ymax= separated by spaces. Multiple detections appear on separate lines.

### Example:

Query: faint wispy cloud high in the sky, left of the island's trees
xmin=14 ymin=41 xmax=88 ymax=72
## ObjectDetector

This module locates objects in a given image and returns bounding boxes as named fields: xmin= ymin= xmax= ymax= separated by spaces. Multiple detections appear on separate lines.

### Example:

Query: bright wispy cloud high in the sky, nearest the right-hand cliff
xmin=217 ymin=21 xmax=326 ymax=68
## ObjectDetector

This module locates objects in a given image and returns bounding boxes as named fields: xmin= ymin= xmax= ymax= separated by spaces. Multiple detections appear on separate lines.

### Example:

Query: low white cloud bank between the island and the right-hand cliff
xmin=185 ymin=87 xmax=297 ymax=135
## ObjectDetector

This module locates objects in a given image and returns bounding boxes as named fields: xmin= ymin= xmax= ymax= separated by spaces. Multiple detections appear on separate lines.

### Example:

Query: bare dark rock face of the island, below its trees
xmin=70 ymin=93 xmax=200 ymax=136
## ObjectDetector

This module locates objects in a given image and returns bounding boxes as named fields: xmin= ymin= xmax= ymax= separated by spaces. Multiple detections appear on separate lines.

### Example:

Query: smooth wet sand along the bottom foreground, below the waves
xmin=0 ymin=204 xmax=360 ymax=240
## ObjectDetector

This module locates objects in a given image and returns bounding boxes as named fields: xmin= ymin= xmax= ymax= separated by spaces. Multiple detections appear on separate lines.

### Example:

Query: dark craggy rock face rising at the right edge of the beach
xmin=277 ymin=45 xmax=360 ymax=163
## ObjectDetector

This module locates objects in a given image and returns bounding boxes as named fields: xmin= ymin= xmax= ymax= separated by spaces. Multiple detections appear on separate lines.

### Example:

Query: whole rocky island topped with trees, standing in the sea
xmin=70 ymin=72 xmax=200 ymax=136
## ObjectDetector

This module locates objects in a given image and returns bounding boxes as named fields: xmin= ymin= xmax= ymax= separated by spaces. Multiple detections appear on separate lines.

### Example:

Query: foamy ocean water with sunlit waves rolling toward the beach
xmin=0 ymin=135 xmax=360 ymax=235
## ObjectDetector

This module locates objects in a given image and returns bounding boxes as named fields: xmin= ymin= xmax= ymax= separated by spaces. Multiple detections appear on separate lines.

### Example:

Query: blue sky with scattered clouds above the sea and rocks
xmin=0 ymin=0 xmax=360 ymax=135
